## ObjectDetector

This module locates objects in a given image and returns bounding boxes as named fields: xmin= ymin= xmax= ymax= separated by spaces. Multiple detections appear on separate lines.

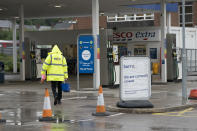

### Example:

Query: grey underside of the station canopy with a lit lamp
xmin=0 ymin=0 xmax=196 ymax=19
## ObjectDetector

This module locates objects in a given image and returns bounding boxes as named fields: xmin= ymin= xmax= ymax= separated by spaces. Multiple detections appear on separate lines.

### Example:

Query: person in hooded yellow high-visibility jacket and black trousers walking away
xmin=41 ymin=45 xmax=68 ymax=105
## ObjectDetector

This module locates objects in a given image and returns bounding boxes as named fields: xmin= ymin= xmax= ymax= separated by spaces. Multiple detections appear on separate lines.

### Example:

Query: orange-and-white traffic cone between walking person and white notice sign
xmin=92 ymin=86 xmax=109 ymax=116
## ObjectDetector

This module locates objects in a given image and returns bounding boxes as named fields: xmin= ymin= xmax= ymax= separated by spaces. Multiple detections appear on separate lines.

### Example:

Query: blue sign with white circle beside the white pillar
xmin=78 ymin=35 xmax=94 ymax=73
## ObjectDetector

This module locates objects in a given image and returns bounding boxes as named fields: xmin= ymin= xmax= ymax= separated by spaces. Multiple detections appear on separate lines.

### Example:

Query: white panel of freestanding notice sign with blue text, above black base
xmin=120 ymin=57 xmax=151 ymax=101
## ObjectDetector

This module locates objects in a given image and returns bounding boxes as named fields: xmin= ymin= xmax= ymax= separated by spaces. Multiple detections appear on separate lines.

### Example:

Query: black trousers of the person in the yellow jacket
xmin=51 ymin=81 xmax=62 ymax=100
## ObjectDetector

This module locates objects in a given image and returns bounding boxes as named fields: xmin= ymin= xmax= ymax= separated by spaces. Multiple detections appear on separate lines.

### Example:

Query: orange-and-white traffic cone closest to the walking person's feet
xmin=39 ymin=88 xmax=55 ymax=121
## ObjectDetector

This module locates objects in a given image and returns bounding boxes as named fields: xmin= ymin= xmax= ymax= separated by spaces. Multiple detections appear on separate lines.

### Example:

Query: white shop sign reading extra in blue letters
xmin=113 ymin=30 xmax=161 ymax=42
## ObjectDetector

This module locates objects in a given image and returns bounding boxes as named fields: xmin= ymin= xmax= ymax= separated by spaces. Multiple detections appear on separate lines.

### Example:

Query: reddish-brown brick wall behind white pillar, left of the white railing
xmin=74 ymin=16 xmax=107 ymax=29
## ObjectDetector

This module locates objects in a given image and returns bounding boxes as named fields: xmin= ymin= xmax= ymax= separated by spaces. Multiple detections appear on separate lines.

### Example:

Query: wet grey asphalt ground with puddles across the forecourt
xmin=0 ymin=76 xmax=197 ymax=131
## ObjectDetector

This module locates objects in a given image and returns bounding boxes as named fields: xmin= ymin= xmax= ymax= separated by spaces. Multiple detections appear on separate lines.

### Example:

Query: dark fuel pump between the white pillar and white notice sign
xmin=100 ymin=29 xmax=127 ymax=88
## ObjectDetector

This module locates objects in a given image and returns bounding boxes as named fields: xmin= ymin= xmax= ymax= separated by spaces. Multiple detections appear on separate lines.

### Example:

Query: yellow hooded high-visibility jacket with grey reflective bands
xmin=41 ymin=45 xmax=68 ymax=81
